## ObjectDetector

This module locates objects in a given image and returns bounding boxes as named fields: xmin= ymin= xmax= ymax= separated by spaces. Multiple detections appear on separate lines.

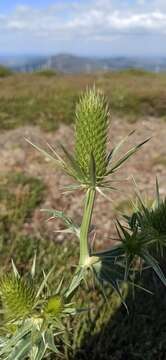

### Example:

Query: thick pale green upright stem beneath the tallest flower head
xmin=79 ymin=188 xmax=96 ymax=266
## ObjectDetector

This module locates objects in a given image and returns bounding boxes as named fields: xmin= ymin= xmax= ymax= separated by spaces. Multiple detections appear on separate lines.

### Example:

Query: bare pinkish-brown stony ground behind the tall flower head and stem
xmin=0 ymin=118 xmax=166 ymax=247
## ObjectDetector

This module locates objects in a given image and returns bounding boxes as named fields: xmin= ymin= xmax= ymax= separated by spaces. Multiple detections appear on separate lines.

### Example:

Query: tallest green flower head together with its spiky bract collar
xmin=26 ymin=87 xmax=149 ymax=193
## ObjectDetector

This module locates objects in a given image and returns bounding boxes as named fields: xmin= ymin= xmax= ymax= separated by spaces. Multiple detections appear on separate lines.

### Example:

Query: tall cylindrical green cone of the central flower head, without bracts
xmin=75 ymin=88 xmax=110 ymax=179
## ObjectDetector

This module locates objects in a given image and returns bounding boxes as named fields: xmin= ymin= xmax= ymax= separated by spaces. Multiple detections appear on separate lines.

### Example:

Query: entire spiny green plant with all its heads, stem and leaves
xmin=0 ymin=88 xmax=166 ymax=360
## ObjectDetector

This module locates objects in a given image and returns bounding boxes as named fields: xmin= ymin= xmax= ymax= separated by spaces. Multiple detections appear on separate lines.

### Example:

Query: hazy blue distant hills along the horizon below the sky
xmin=0 ymin=54 xmax=166 ymax=73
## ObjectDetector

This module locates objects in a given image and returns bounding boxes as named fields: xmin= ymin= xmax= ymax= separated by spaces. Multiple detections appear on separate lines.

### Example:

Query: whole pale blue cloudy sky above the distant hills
xmin=0 ymin=0 xmax=166 ymax=57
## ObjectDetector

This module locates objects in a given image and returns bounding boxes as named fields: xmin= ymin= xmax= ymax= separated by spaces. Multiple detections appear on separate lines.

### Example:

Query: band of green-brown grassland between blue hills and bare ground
xmin=0 ymin=70 xmax=166 ymax=130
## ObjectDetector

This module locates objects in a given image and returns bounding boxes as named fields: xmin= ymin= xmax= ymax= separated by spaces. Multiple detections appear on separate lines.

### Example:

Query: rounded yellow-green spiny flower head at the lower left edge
xmin=0 ymin=274 xmax=35 ymax=320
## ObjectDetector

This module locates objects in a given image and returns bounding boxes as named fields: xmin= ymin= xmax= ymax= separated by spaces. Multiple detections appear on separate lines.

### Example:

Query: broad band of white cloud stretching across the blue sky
xmin=0 ymin=0 xmax=166 ymax=54
